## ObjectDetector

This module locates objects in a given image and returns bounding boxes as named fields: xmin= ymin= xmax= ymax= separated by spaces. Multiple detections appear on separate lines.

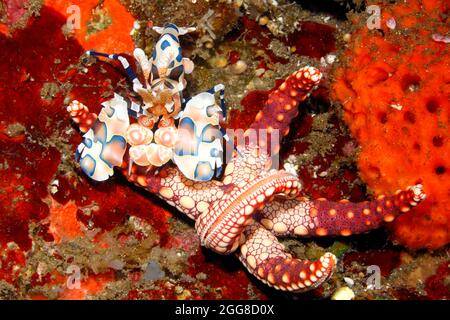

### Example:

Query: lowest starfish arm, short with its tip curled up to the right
xmin=237 ymin=223 xmax=336 ymax=292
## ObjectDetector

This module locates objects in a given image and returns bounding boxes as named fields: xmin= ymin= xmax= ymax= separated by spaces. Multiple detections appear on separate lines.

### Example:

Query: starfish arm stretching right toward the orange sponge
xmin=260 ymin=185 xmax=425 ymax=236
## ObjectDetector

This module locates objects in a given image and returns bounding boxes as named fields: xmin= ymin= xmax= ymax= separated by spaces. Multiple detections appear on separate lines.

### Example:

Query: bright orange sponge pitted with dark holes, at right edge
xmin=332 ymin=0 xmax=450 ymax=249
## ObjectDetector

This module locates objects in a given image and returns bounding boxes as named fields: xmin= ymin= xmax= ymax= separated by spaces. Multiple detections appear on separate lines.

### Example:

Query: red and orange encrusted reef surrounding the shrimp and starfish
xmin=0 ymin=0 xmax=450 ymax=300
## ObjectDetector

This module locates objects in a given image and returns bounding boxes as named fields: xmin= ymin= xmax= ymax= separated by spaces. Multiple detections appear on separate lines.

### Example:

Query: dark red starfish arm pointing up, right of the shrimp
xmin=246 ymin=66 xmax=322 ymax=154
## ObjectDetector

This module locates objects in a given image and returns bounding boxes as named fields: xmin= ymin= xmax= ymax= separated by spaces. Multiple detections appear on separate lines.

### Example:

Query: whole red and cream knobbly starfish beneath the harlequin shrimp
xmin=68 ymin=67 xmax=425 ymax=292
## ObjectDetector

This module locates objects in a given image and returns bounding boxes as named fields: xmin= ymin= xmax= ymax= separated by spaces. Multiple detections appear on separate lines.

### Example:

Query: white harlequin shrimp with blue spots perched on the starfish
xmin=68 ymin=24 xmax=229 ymax=181
